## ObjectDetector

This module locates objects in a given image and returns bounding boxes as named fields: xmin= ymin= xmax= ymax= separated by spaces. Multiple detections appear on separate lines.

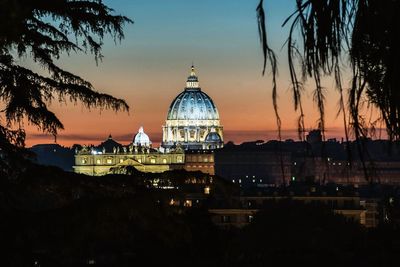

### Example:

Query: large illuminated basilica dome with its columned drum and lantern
xmin=162 ymin=66 xmax=223 ymax=149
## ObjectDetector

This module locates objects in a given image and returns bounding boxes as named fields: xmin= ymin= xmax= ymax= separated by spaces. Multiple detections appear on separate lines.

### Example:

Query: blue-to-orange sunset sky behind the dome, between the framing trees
xmin=22 ymin=0 xmax=352 ymax=146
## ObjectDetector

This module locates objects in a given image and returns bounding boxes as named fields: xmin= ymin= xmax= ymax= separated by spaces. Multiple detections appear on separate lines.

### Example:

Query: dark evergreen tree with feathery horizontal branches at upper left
xmin=0 ymin=0 xmax=132 ymax=176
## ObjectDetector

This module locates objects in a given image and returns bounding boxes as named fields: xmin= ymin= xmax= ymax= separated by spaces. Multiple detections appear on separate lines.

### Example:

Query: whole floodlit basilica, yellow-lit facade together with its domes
xmin=73 ymin=66 xmax=224 ymax=175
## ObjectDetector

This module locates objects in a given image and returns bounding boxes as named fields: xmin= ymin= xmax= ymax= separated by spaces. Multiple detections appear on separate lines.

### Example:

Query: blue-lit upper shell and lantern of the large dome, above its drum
xmin=167 ymin=66 xmax=219 ymax=120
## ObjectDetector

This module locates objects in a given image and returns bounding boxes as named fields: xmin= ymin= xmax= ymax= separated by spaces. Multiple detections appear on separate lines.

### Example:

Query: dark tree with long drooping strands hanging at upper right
xmin=257 ymin=0 xmax=400 ymax=143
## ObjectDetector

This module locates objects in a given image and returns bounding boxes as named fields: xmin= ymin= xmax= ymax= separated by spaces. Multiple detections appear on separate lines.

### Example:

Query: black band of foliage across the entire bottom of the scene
xmin=0 ymin=166 xmax=400 ymax=266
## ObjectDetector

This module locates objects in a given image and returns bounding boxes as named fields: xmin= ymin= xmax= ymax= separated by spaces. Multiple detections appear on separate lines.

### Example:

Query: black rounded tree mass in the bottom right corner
xmin=225 ymin=200 xmax=400 ymax=266
